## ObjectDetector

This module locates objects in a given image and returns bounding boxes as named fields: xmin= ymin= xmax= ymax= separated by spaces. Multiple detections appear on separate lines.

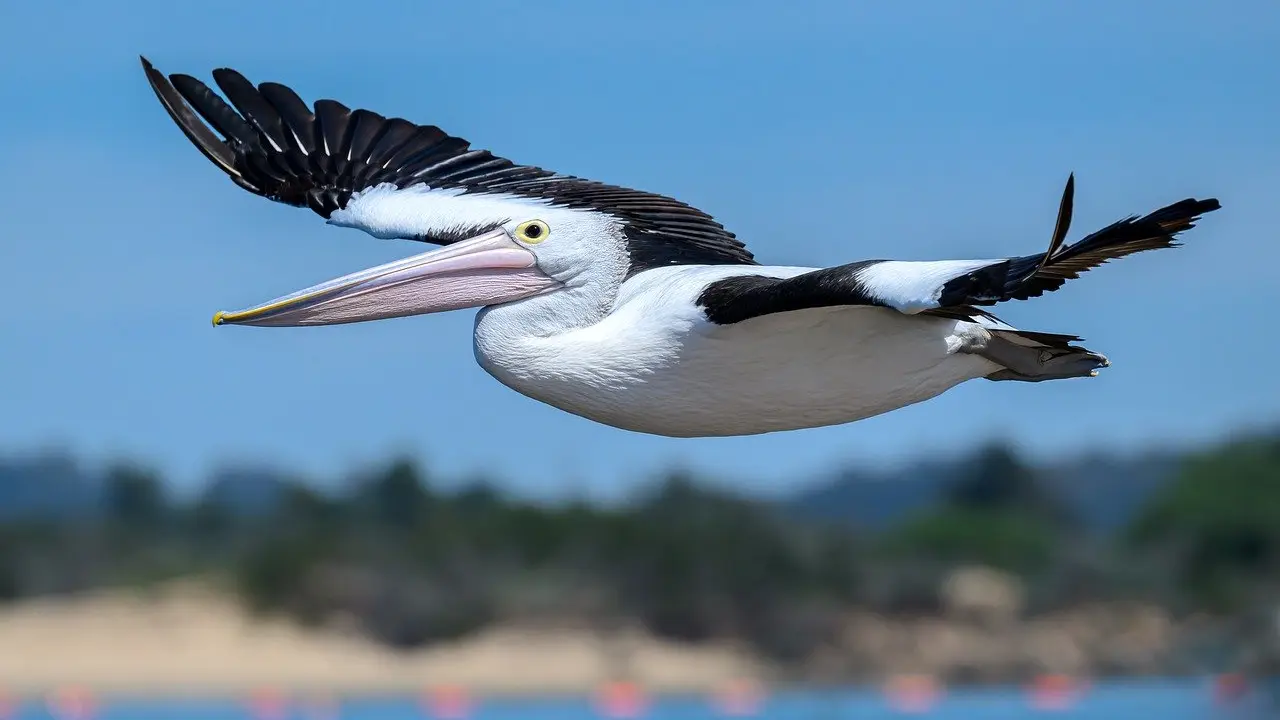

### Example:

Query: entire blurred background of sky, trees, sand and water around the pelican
xmin=0 ymin=0 xmax=1280 ymax=720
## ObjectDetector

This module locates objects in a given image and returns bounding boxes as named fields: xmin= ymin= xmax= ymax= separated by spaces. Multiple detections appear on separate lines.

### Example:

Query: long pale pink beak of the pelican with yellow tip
xmin=214 ymin=228 xmax=559 ymax=327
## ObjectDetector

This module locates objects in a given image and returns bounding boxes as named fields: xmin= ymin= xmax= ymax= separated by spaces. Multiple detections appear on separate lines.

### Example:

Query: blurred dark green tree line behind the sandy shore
xmin=0 ymin=422 xmax=1280 ymax=661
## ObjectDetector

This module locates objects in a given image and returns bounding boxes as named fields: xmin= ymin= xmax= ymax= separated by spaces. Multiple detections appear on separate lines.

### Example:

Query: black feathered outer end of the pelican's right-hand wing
xmin=938 ymin=174 xmax=1221 ymax=307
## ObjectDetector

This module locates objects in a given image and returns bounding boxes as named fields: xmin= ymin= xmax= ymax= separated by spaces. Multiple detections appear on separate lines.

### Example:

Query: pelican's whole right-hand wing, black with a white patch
xmin=699 ymin=176 xmax=1221 ymax=324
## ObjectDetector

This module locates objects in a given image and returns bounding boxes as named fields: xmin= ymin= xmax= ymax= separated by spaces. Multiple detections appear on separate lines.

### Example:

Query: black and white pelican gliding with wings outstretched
xmin=142 ymin=58 xmax=1219 ymax=437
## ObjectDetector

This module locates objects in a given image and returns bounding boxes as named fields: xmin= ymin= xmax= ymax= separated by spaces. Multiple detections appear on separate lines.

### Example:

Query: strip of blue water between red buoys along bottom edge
xmin=12 ymin=680 xmax=1280 ymax=720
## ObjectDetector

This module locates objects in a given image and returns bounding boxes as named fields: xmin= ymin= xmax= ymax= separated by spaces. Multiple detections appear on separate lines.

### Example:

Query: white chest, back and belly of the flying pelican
xmin=475 ymin=265 xmax=1000 ymax=437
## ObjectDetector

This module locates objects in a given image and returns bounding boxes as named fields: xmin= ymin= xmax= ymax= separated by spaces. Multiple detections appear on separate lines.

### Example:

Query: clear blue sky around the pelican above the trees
xmin=0 ymin=0 xmax=1280 ymax=496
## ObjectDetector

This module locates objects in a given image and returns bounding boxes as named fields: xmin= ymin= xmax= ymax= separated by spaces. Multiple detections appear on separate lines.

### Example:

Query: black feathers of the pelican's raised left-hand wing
xmin=142 ymin=58 xmax=755 ymax=269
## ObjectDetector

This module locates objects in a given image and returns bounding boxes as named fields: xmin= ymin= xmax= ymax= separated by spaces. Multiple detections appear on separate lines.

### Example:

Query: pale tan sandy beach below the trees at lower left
xmin=0 ymin=584 xmax=763 ymax=696
